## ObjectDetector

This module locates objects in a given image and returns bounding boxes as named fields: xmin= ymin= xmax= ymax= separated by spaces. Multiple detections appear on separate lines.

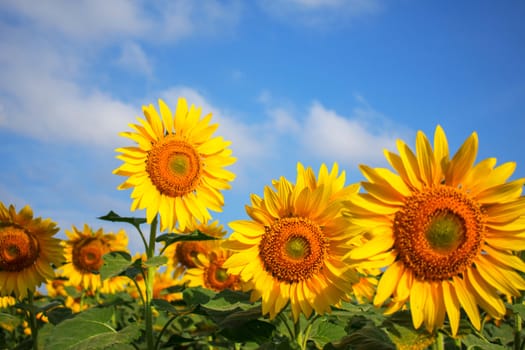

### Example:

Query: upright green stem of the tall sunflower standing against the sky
xmin=144 ymin=216 xmax=158 ymax=350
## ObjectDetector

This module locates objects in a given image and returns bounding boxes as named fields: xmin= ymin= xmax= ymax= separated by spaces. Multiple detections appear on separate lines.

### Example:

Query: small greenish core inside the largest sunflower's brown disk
xmin=426 ymin=211 xmax=465 ymax=253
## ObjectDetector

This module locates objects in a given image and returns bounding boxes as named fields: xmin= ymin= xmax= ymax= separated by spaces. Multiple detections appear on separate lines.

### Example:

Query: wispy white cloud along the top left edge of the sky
xmin=0 ymin=0 xmax=242 ymax=45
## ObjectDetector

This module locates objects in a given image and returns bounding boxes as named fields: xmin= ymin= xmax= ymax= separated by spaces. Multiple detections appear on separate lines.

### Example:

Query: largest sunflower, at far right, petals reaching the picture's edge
xmin=349 ymin=126 xmax=525 ymax=335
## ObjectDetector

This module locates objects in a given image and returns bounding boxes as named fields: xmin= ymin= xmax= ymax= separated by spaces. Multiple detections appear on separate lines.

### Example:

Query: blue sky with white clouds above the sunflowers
xmin=0 ymin=0 xmax=525 ymax=252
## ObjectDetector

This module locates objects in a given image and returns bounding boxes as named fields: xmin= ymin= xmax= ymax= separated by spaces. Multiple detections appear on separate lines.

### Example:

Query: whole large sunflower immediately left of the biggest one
xmin=223 ymin=163 xmax=359 ymax=320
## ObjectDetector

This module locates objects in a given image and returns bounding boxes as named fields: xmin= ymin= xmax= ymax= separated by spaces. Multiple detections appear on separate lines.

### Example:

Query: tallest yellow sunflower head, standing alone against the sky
xmin=114 ymin=98 xmax=236 ymax=231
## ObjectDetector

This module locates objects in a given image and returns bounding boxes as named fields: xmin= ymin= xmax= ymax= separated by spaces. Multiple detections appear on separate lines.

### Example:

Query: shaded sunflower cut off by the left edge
xmin=0 ymin=202 xmax=64 ymax=298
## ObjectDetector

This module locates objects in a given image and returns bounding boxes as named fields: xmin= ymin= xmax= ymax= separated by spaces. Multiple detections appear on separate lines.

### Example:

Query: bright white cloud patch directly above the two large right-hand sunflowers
xmin=302 ymin=102 xmax=399 ymax=164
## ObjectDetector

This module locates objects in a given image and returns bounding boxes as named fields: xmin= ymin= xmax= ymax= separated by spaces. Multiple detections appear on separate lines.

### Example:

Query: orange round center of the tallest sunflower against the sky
xmin=146 ymin=135 xmax=202 ymax=198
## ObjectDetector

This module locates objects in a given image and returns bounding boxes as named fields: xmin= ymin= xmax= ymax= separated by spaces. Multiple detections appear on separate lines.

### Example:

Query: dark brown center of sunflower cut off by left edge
xmin=0 ymin=226 xmax=40 ymax=272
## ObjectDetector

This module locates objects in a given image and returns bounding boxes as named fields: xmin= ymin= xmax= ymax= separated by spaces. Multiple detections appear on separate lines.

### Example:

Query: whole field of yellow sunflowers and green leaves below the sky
xmin=0 ymin=98 xmax=525 ymax=350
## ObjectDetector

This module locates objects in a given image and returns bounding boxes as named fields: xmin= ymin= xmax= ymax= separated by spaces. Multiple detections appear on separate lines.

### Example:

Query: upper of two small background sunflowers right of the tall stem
xmin=163 ymin=219 xmax=226 ymax=277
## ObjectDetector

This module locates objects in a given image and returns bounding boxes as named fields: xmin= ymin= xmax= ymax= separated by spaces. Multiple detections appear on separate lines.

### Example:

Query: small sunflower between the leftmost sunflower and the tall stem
xmin=62 ymin=225 xmax=128 ymax=293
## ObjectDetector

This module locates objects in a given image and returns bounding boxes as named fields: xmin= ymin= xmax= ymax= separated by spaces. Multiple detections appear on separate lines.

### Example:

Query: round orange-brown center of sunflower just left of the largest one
xmin=259 ymin=217 xmax=328 ymax=283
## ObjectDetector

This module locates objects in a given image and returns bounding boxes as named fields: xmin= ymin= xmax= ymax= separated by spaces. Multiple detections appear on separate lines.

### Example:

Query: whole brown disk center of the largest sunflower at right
xmin=394 ymin=186 xmax=485 ymax=281
